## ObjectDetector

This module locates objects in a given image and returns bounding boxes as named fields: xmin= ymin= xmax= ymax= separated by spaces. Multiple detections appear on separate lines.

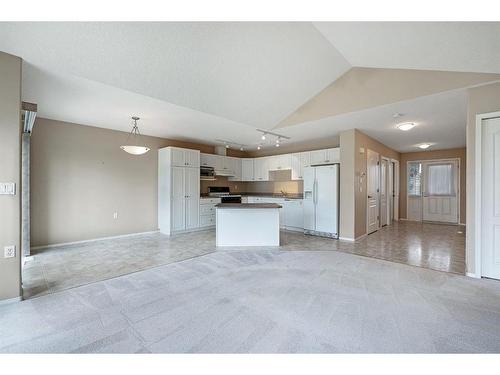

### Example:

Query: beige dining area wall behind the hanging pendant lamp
xmin=31 ymin=118 xmax=238 ymax=247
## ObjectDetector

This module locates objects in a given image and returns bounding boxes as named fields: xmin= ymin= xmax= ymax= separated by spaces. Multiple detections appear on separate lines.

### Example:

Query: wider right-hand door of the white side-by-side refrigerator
xmin=315 ymin=165 xmax=338 ymax=234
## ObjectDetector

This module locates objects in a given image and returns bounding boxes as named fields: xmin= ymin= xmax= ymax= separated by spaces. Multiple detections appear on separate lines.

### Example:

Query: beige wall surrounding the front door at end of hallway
xmin=399 ymin=147 xmax=467 ymax=224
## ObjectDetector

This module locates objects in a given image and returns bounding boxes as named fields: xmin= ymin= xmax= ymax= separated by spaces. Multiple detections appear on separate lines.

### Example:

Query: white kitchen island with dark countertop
xmin=215 ymin=203 xmax=281 ymax=246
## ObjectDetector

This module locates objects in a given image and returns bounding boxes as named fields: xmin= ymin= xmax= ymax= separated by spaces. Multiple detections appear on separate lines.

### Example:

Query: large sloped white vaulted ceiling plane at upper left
xmin=0 ymin=22 xmax=350 ymax=128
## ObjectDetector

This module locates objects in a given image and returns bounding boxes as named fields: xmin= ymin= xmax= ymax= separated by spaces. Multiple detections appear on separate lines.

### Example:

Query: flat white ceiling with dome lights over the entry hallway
xmin=280 ymin=89 xmax=467 ymax=152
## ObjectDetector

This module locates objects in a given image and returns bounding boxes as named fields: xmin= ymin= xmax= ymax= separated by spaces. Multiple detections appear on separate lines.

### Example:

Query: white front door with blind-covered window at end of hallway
xmin=422 ymin=160 xmax=458 ymax=223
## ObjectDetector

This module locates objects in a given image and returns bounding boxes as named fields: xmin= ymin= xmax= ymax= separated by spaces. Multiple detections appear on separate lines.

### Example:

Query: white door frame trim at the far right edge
xmin=465 ymin=111 xmax=500 ymax=279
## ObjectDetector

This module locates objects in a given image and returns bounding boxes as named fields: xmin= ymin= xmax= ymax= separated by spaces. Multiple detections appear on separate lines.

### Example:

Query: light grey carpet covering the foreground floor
xmin=0 ymin=249 xmax=500 ymax=353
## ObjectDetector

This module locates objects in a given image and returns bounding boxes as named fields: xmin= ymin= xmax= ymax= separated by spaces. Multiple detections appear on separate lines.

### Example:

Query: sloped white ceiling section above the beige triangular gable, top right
xmin=314 ymin=22 xmax=500 ymax=73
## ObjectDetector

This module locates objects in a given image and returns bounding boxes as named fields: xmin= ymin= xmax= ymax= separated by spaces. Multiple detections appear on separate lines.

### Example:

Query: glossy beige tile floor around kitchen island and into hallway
xmin=23 ymin=221 xmax=465 ymax=298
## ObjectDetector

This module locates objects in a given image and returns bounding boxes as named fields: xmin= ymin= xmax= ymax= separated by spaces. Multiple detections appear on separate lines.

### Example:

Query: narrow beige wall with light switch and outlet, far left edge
xmin=0 ymin=52 xmax=21 ymax=300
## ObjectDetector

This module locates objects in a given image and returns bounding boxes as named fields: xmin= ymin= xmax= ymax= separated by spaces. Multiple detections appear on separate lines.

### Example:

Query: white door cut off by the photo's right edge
xmin=481 ymin=118 xmax=500 ymax=279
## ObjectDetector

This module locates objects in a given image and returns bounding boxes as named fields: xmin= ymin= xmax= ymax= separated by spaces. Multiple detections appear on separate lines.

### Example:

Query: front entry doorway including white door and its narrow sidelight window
xmin=406 ymin=159 xmax=460 ymax=224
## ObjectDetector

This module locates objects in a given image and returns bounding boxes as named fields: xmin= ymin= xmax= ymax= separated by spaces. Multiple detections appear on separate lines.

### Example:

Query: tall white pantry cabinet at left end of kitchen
xmin=158 ymin=147 xmax=200 ymax=235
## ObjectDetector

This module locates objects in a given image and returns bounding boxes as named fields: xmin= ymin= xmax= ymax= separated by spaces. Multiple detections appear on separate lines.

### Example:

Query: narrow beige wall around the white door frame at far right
xmin=466 ymin=83 xmax=500 ymax=273
